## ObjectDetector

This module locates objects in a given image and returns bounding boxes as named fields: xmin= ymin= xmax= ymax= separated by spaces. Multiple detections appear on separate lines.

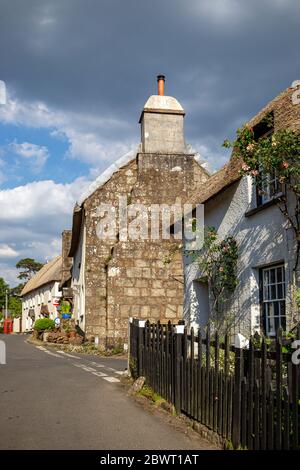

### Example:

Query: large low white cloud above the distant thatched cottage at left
xmin=0 ymin=178 xmax=91 ymax=285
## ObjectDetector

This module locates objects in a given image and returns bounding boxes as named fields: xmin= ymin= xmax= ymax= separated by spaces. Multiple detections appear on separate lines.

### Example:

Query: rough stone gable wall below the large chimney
xmin=84 ymin=153 xmax=208 ymax=346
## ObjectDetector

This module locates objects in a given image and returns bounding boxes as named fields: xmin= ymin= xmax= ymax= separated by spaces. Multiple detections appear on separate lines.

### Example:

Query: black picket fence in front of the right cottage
xmin=130 ymin=319 xmax=300 ymax=450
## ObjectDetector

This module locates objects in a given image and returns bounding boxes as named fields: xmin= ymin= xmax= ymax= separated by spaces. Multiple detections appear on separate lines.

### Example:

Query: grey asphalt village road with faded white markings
xmin=0 ymin=335 xmax=214 ymax=450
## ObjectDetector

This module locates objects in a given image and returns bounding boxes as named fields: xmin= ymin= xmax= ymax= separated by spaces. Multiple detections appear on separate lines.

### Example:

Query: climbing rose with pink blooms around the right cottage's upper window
xmin=223 ymin=126 xmax=300 ymax=271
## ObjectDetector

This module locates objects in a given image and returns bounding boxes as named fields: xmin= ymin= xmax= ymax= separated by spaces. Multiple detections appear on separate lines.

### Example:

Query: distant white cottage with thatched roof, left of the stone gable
xmin=21 ymin=256 xmax=62 ymax=331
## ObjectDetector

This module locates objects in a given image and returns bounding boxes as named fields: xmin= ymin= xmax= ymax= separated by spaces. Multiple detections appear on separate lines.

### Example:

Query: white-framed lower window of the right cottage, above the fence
xmin=260 ymin=264 xmax=286 ymax=336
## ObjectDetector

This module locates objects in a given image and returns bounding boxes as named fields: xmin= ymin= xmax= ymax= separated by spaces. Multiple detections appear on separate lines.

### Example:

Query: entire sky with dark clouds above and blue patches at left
xmin=0 ymin=0 xmax=300 ymax=284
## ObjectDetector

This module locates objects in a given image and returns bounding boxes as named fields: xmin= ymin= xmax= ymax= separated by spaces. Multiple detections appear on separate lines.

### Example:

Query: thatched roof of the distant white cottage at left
xmin=21 ymin=256 xmax=62 ymax=296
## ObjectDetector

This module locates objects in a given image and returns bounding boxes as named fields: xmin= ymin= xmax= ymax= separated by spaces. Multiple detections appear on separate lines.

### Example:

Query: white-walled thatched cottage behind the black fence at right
xmin=184 ymin=87 xmax=300 ymax=337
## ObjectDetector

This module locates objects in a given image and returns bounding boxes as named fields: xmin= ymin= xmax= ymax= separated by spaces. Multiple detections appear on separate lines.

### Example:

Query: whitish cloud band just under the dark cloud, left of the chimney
xmin=0 ymin=97 xmax=134 ymax=167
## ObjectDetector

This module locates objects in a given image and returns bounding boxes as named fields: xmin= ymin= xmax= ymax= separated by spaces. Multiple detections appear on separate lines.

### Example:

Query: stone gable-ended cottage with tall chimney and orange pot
xmin=69 ymin=76 xmax=209 ymax=346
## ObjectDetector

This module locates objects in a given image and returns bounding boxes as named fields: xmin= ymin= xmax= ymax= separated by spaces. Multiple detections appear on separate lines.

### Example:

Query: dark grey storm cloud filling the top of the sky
xmin=0 ymin=0 xmax=300 ymax=167
